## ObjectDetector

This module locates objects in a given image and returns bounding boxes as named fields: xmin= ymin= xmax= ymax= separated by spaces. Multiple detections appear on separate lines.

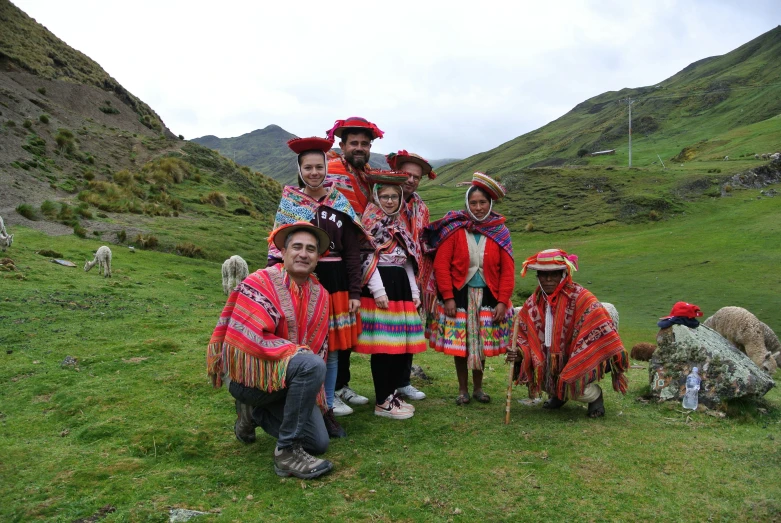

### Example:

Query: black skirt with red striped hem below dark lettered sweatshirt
xmin=315 ymin=261 xmax=361 ymax=351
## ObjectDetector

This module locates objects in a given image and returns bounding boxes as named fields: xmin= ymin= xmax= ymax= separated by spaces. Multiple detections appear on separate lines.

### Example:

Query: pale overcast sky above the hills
xmin=12 ymin=0 xmax=781 ymax=159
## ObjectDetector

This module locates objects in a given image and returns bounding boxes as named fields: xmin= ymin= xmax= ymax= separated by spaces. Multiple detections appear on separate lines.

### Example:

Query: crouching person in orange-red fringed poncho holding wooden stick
xmin=507 ymin=249 xmax=629 ymax=418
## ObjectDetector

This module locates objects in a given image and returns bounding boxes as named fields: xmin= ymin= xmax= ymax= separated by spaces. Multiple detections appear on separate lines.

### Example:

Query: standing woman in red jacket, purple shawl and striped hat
xmin=423 ymin=172 xmax=515 ymax=405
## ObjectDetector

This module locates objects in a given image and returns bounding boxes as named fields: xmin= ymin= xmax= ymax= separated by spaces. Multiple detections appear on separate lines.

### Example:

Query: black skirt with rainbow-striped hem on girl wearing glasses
xmin=355 ymin=267 xmax=426 ymax=354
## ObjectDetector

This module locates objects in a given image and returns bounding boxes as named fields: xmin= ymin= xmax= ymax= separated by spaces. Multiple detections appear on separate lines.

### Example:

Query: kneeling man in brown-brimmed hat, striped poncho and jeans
xmin=206 ymin=222 xmax=333 ymax=479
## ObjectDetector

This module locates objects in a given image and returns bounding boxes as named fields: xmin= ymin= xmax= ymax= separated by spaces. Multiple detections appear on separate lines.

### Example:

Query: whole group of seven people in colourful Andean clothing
xmin=207 ymin=117 xmax=628 ymax=479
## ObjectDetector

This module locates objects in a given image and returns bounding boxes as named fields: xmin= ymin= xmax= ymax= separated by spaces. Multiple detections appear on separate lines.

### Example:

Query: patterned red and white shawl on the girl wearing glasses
xmin=361 ymin=203 xmax=421 ymax=285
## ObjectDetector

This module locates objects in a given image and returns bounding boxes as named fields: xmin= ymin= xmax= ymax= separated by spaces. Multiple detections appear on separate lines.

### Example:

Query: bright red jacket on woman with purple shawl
xmin=434 ymin=229 xmax=515 ymax=308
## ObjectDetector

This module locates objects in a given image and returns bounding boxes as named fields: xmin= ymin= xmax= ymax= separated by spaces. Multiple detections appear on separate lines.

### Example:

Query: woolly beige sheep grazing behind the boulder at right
xmin=703 ymin=307 xmax=778 ymax=376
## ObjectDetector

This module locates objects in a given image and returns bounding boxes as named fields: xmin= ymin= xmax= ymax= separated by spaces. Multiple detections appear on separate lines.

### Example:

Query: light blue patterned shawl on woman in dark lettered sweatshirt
xmin=268 ymin=182 xmax=365 ymax=260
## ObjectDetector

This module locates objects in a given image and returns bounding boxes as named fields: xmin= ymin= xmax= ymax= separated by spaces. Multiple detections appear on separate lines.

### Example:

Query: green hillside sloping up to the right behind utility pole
xmin=434 ymin=27 xmax=781 ymax=183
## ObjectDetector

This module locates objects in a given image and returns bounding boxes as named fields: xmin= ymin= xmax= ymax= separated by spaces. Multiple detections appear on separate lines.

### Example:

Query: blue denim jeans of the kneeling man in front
xmin=228 ymin=351 xmax=329 ymax=454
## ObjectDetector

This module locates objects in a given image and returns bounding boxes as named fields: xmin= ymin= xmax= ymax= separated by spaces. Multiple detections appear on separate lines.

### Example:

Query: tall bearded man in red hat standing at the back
xmin=326 ymin=116 xmax=384 ymax=416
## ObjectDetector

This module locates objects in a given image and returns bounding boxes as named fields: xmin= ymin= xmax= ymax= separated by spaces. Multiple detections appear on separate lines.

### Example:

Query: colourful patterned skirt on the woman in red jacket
xmin=426 ymin=285 xmax=513 ymax=370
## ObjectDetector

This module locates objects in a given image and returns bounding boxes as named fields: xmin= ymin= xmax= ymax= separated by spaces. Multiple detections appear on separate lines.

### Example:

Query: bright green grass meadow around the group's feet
xmin=0 ymin=182 xmax=781 ymax=522
